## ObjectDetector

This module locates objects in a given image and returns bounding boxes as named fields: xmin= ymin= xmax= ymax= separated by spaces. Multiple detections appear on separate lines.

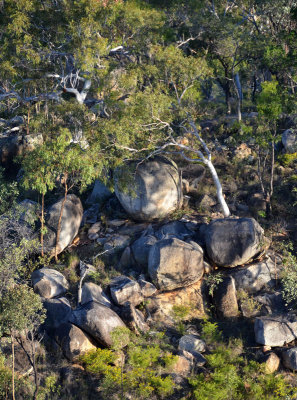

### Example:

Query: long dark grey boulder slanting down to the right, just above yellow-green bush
xmin=70 ymin=301 xmax=126 ymax=347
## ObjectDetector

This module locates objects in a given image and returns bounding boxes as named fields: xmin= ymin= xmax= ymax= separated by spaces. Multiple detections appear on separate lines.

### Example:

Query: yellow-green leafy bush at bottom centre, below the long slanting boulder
xmin=81 ymin=330 xmax=175 ymax=399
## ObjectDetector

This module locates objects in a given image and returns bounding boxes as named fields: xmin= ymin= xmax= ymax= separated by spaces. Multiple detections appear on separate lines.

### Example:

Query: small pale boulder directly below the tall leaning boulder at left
xmin=31 ymin=268 xmax=69 ymax=299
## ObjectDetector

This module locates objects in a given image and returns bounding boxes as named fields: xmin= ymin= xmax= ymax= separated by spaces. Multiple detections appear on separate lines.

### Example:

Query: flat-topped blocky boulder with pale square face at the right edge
xmin=254 ymin=315 xmax=297 ymax=347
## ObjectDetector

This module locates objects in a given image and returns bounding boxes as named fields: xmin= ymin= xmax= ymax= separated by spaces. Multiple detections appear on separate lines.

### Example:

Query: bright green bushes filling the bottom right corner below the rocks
xmin=189 ymin=322 xmax=297 ymax=400
